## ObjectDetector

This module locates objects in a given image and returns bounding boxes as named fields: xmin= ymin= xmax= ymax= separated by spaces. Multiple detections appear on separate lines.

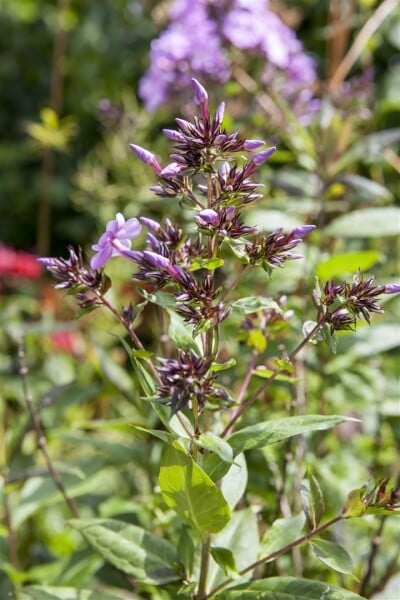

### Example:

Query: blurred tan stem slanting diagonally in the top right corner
xmin=329 ymin=0 xmax=399 ymax=90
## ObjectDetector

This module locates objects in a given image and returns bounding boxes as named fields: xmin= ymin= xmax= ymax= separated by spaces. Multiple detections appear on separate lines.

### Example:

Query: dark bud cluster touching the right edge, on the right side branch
xmin=322 ymin=274 xmax=400 ymax=332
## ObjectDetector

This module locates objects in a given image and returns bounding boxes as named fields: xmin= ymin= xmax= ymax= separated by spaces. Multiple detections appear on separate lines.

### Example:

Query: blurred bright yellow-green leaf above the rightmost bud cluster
xmin=316 ymin=250 xmax=383 ymax=281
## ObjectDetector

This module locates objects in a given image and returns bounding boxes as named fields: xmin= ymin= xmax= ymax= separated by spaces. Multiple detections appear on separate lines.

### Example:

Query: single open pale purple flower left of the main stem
xmin=90 ymin=213 xmax=142 ymax=269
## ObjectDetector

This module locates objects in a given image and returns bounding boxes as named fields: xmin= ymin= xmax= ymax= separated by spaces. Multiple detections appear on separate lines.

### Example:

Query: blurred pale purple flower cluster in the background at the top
xmin=139 ymin=0 xmax=317 ymax=119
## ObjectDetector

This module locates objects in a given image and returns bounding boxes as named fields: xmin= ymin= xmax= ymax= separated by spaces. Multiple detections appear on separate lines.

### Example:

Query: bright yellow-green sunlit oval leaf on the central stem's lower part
xmin=159 ymin=443 xmax=230 ymax=533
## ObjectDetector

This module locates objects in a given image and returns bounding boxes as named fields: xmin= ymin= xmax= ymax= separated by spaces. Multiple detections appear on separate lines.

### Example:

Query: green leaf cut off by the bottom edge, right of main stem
xmin=215 ymin=577 xmax=365 ymax=600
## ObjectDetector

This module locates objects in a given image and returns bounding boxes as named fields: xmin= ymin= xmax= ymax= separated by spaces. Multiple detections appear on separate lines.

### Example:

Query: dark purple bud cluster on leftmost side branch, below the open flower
xmin=38 ymin=246 xmax=111 ymax=308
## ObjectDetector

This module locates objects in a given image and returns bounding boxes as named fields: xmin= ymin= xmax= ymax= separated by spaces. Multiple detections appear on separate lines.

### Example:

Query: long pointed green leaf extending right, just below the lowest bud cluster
xmin=228 ymin=415 xmax=354 ymax=455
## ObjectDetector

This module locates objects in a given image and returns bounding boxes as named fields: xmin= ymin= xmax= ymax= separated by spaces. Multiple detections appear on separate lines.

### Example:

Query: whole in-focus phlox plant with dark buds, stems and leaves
xmin=27 ymin=79 xmax=400 ymax=600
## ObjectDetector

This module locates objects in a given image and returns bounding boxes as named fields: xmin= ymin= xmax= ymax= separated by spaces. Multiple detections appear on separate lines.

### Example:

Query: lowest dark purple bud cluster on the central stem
xmin=157 ymin=350 xmax=231 ymax=414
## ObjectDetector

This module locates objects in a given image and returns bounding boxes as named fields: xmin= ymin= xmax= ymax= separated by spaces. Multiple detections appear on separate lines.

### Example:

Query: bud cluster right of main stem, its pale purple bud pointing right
xmin=246 ymin=225 xmax=315 ymax=269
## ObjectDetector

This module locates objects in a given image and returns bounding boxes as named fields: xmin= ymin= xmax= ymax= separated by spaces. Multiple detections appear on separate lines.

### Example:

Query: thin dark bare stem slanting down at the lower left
xmin=18 ymin=337 xmax=79 ymax=519
